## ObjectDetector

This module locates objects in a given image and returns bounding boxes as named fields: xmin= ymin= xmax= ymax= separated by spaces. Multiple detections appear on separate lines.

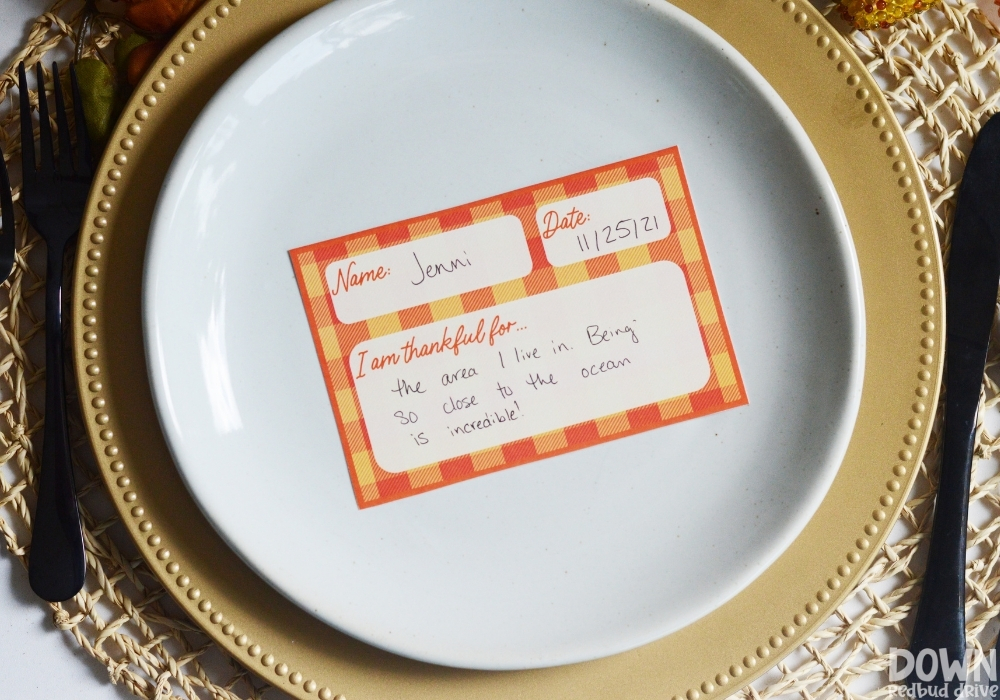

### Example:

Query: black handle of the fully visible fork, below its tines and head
xmin=28 ymin=246 xmax=86 ymax=602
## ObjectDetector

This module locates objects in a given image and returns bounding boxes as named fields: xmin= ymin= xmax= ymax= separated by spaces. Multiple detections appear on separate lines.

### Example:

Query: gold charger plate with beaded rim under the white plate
xmin=72 ymin=0 xmax=944 ymax=700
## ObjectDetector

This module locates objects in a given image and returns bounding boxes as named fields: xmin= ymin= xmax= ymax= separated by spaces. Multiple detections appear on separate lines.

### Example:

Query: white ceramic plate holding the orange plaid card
xmin=144 ymin=0 xmax=864 ymax=669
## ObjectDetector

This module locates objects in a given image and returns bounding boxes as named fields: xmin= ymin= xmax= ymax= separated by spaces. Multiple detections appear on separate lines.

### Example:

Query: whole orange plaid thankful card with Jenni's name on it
xmin=290 ymin=147 xmax=747 ymax=508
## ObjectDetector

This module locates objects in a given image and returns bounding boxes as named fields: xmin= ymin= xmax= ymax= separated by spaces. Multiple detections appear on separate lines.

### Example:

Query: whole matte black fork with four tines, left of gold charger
xmin=18 ymin=63 xmax=93 ymax=602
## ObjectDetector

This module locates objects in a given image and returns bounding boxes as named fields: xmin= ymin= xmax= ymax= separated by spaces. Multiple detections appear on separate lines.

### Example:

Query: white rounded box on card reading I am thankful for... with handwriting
xmin=350 ymin=262 xmax=710 ymax=473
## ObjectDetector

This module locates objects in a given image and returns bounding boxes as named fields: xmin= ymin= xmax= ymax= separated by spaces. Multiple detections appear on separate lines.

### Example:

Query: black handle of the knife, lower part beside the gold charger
xmin=910 ymin=337 xmax=986 ymax=676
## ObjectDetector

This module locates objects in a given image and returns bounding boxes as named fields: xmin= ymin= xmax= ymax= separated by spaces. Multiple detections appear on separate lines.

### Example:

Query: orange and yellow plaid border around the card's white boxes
xmin=289 ymin=147 xmax=747 ymax=508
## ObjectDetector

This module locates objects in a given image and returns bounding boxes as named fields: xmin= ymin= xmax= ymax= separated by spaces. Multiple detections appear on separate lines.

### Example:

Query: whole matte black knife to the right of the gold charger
xmin=909 ymin=116 xmax=1000 ymax=698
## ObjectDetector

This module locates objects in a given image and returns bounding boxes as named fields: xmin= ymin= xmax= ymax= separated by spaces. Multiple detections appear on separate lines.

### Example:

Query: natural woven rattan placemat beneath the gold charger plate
xmin=0 ymin=0 xmax=1000 ymax=700
